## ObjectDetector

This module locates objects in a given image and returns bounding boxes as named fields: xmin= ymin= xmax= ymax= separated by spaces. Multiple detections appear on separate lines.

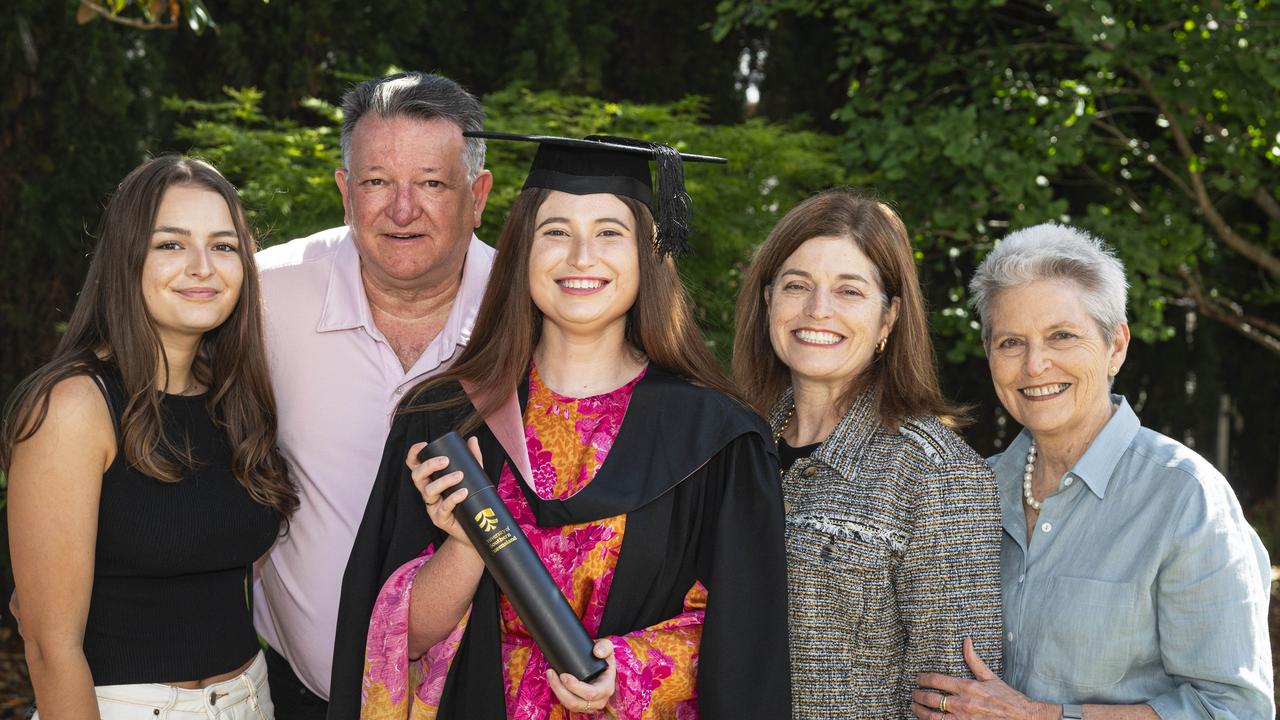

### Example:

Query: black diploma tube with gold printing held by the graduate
xmin=419 ymin=433 xmax=607 ymax=682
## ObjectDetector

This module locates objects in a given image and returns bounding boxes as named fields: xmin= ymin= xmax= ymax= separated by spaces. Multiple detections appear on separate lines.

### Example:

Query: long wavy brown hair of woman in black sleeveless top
xmin=0 ymin=155 xmax=298 ymax=519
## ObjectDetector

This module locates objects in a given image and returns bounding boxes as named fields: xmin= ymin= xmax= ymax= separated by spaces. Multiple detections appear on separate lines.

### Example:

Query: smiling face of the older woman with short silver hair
xmin=987 ymin=281 xmax=1129 ymax=445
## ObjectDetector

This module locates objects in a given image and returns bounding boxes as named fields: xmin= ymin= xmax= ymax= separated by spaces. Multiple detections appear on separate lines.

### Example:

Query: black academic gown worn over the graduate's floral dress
xmin=329 ymin=364 xmax=791 ymax=720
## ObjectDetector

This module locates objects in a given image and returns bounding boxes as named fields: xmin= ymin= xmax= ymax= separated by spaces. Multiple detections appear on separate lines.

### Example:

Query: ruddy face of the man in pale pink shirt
xmin=335 ymin=114 xmax=493 ymax=290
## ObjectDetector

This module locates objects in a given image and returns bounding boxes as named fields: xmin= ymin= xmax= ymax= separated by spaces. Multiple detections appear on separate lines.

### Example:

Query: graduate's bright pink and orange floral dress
xmin=361 ymin=368 xmax=707 ymax=720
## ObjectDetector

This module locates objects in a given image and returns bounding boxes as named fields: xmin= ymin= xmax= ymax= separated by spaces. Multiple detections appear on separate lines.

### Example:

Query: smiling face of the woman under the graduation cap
xmin=529 ymin=191 xmax=640 ymax=336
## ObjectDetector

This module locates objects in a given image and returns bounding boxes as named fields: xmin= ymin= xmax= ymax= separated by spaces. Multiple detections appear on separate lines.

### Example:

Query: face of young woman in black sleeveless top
xmin=142 ymin=186 xmax=248 ymax=345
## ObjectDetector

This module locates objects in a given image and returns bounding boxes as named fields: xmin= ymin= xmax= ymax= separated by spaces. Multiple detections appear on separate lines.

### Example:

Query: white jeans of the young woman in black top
xmin=32 ymin=652 xmax=275 ymax=720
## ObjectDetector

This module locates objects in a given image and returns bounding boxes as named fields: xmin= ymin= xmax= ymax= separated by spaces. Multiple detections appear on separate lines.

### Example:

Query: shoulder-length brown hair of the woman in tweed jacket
xmin=733 ymin=188 xmax=964 ymax=429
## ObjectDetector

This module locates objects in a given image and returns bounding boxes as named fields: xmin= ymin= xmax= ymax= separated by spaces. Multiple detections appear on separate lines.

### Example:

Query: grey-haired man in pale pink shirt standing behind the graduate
xmin=253 ymin=73 xmax=494 ymax=720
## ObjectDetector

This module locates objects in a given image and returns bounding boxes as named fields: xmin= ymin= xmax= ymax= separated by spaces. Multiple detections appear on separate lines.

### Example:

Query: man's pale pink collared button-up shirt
xmin=253 ymin=227 xmax=494 ymax=698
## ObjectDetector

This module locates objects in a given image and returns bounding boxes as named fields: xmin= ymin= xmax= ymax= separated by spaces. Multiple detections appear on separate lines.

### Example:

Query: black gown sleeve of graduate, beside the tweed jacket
xmin=698 ymin=433 xmax=791 ymax=720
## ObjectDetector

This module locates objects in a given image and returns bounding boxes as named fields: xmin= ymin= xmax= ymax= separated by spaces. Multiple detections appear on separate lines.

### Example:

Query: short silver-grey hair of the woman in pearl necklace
xmin=969 ymin=223 xmax=1129 ymax=347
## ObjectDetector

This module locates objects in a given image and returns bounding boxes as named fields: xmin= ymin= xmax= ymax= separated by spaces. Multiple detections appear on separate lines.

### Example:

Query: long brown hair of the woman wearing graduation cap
xmin=406 ymin=188 xmax=740 ymax=432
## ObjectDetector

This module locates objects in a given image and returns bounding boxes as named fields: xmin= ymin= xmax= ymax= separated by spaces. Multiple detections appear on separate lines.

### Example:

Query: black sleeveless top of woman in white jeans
xmin=83 ymin=364 xmax=280 ymax=685
